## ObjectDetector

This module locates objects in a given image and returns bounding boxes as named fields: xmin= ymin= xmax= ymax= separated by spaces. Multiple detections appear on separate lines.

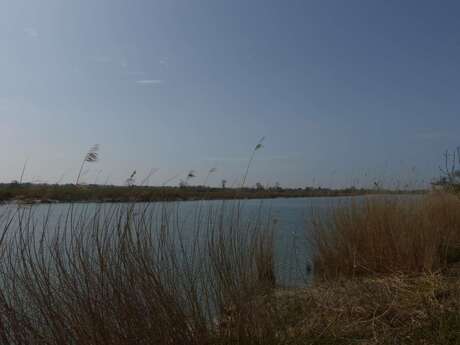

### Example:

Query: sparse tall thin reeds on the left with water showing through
xmin=0 ymin=205 xmax=279 ymax=345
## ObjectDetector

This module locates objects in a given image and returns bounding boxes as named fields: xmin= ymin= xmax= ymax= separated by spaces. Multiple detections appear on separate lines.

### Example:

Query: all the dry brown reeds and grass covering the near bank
xmin=0 ymin=194 xmax=460 ymax=345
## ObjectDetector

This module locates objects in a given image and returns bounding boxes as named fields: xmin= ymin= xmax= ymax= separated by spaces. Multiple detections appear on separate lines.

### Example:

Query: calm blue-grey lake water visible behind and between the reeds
xmin=0 ymin=196 xmax=413 ymax=286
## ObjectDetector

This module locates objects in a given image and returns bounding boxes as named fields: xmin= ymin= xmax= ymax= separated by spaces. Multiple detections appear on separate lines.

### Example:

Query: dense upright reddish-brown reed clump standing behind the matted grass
xmin=311 ymin=193 xmax=460 ymax=278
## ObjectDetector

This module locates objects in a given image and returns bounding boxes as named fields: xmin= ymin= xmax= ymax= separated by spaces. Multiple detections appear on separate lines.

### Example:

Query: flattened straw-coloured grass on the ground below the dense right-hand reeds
xmin=266 ymin=274 xmax=460 ymax=345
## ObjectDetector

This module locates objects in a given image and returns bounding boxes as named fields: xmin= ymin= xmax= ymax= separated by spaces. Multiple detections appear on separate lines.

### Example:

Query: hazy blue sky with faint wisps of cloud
xmin=0 ymin=0 xmax=460 ymax=187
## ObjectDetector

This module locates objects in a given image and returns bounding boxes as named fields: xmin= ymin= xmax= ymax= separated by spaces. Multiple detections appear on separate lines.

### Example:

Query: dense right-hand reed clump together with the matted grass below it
xmin=280 ymin=189 xmax=460 ymax=345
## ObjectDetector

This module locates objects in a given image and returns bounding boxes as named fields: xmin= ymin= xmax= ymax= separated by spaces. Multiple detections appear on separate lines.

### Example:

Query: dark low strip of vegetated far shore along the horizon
xmin=0 ymin=184 xmax=428 ymax=205
